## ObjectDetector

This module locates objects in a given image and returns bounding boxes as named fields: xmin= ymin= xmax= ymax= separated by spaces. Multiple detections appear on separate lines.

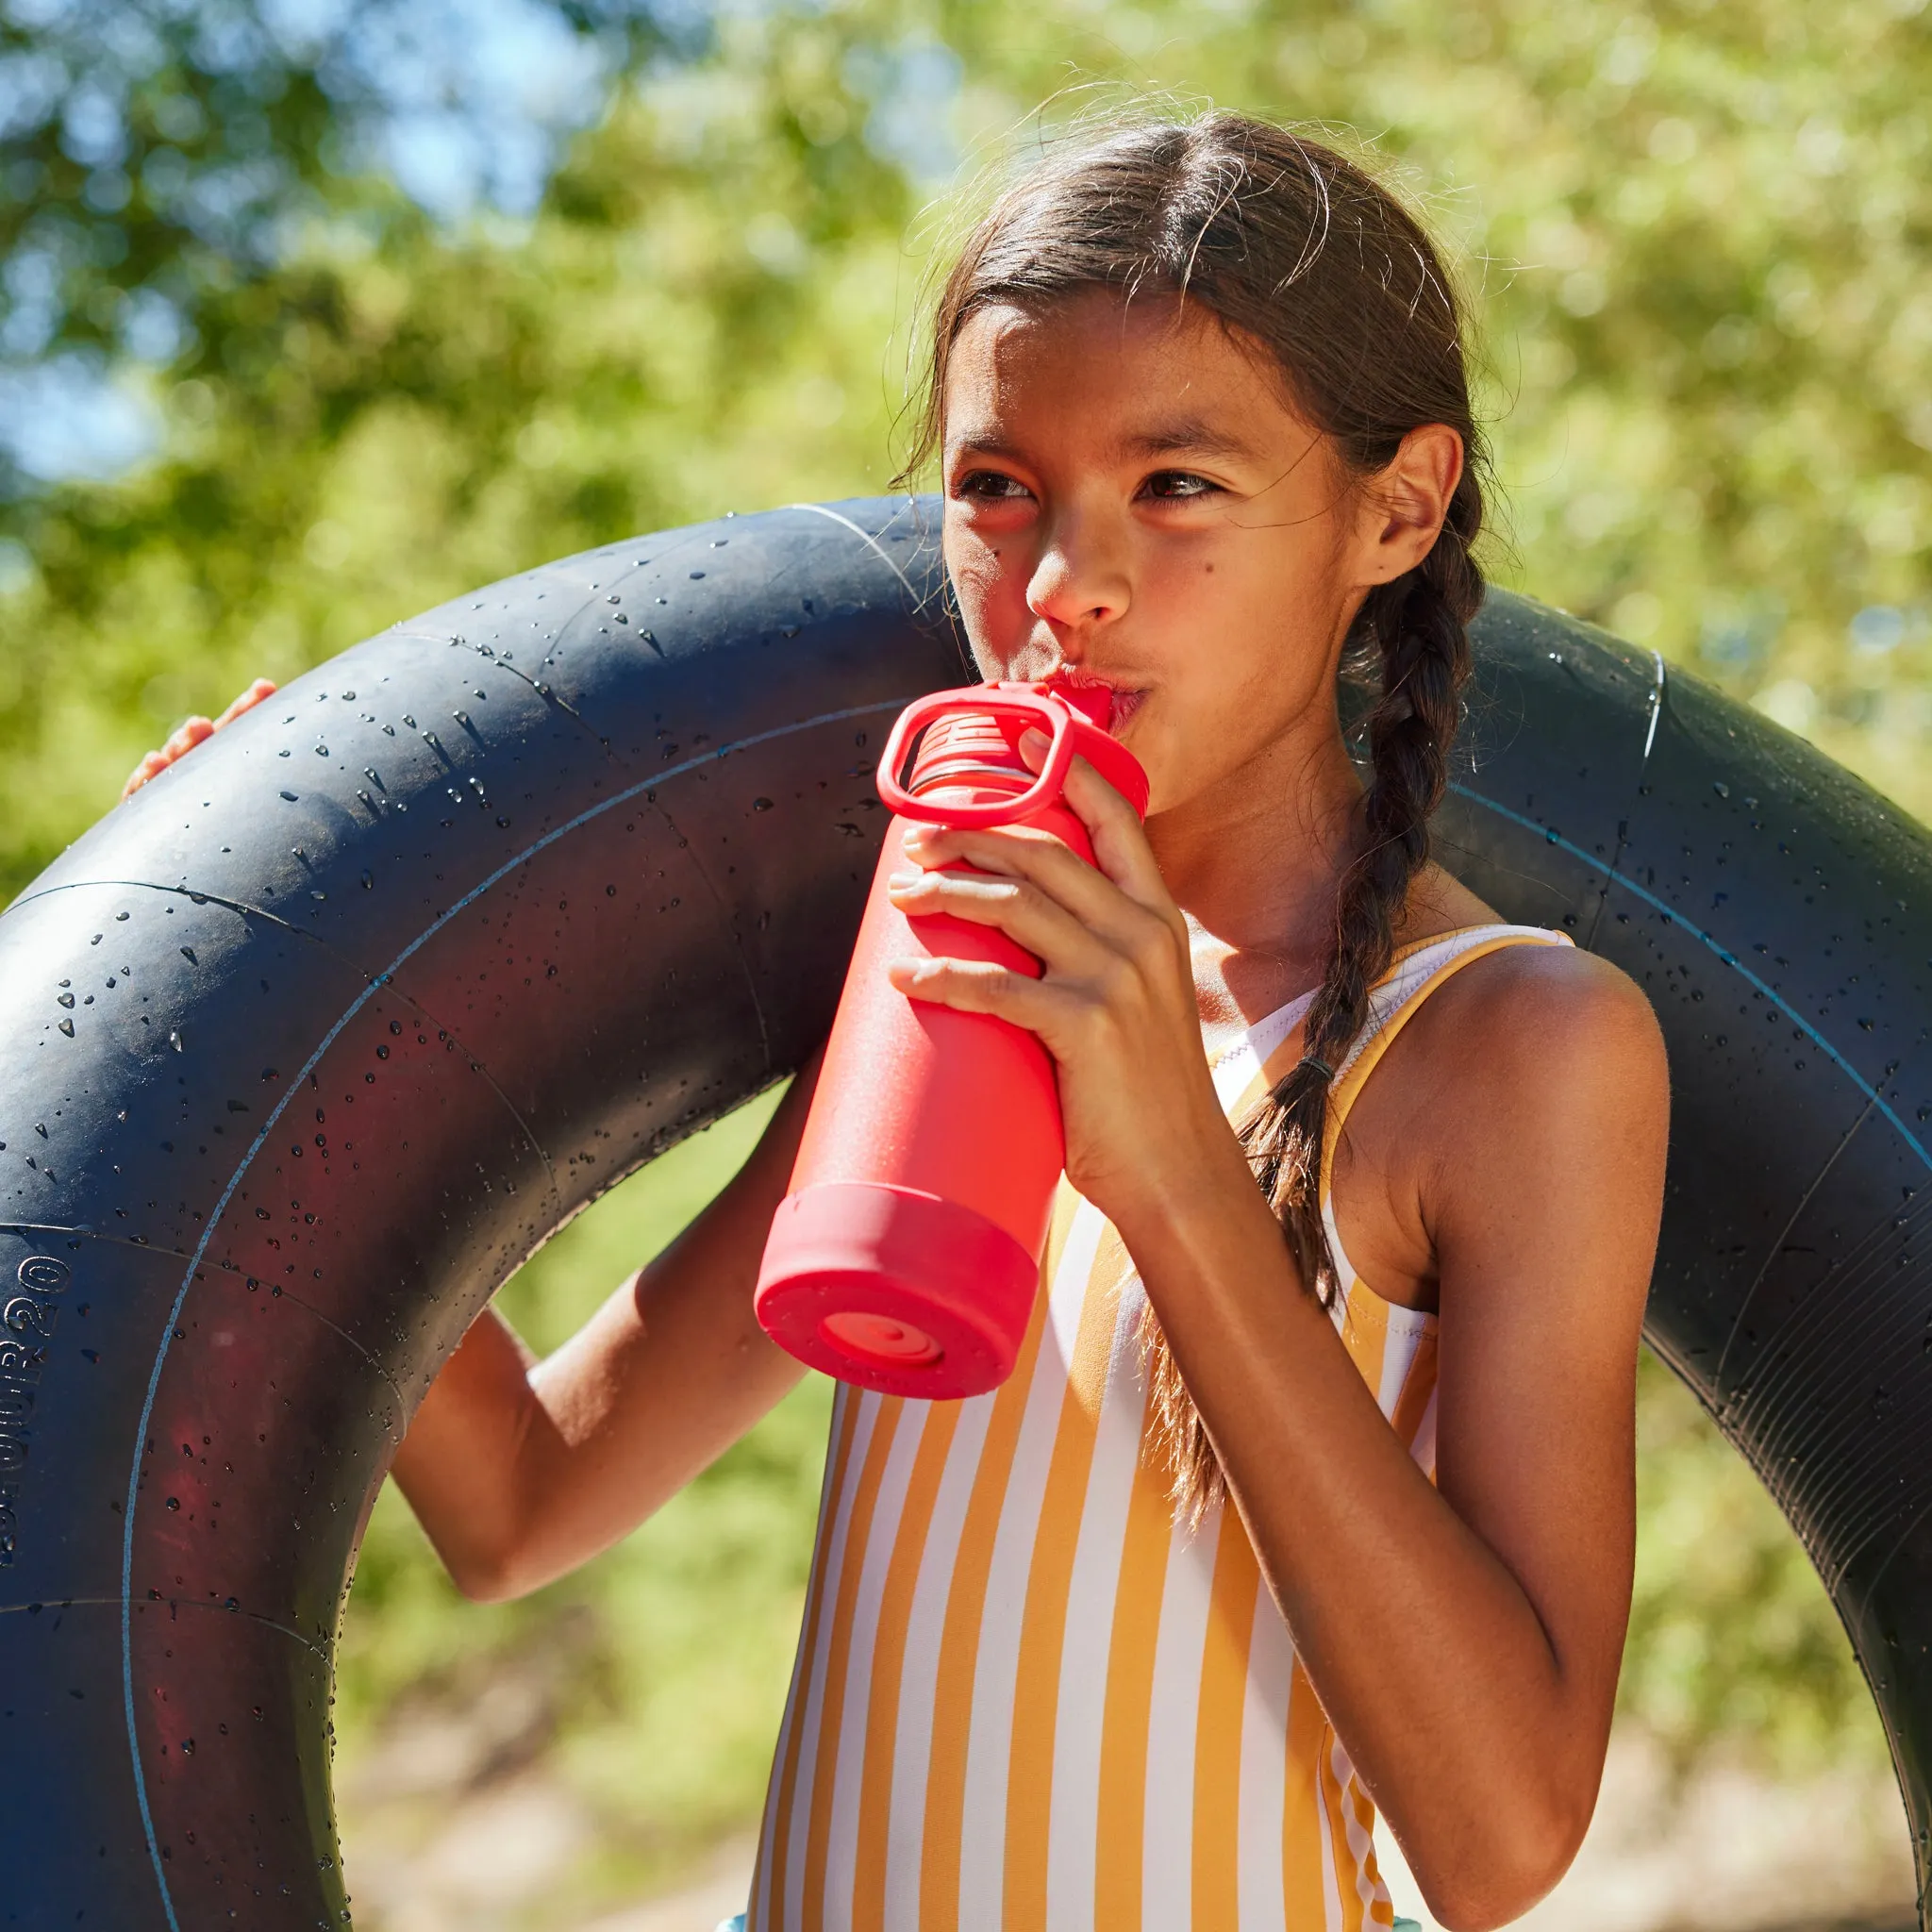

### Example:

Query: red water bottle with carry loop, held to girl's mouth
xmin=758 ymin=684 xmax=1148 ymax=1399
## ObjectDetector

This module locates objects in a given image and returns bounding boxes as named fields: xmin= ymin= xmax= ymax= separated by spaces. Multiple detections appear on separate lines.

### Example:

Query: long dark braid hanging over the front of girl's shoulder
xmin=1140 ymin=471 xmax=1482 ymax=1523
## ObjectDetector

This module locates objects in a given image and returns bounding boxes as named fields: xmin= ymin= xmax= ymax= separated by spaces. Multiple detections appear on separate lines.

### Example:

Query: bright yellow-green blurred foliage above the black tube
xmin=0 ymin=0 xmax=1932 ymax=889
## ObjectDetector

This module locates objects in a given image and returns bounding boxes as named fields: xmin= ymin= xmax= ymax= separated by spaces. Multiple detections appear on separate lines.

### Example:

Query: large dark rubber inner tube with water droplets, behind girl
xmin=0 ymin=498 xmax=1932 ymax=1932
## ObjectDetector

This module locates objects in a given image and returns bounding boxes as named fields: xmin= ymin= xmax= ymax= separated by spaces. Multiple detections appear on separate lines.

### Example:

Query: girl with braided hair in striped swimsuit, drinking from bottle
xmin=140 ymin=116 xmax=1667 ymax=1932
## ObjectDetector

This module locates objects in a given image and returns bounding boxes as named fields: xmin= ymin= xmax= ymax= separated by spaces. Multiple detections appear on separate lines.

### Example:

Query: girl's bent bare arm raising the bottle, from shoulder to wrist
xmin=1121 ymin=953 xmax=1667 ymax=1928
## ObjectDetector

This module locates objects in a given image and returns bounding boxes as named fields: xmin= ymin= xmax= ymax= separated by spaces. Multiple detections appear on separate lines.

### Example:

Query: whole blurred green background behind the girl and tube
xmin=0 ymin=0 xmax=1932 ymax=1932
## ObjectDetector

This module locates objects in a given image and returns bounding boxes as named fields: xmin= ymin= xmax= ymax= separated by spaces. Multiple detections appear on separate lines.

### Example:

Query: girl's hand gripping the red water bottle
xmin=889 ymin=730 xmax=1248 ymax=1233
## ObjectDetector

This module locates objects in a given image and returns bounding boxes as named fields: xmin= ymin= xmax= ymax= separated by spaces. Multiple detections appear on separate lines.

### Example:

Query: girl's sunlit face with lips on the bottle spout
xmin=942 ymin=290 xmax=1460 ymax=811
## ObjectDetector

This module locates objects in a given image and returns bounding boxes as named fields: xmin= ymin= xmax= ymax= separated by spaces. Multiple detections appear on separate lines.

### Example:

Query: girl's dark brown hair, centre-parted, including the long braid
xmin=908 ymin=114 xmax=1486 ymax=1521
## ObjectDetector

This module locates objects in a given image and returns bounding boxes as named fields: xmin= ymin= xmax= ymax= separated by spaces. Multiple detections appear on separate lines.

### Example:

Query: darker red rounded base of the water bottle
xmin=756 ymin=1180 xmax=1040 ymax=1401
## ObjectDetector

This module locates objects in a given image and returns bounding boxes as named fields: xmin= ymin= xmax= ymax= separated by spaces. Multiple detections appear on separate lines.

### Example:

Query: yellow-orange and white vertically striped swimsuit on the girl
xmin=750 ymin=925 xmax=1567 ymax=1932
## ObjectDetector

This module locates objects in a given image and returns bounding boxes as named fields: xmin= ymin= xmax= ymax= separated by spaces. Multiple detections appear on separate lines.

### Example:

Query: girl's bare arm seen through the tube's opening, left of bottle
xmin=394 ymin=1057 xmax=817 ymax=1600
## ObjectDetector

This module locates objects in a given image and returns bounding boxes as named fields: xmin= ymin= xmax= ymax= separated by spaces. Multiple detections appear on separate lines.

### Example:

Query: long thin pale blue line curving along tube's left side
xmin=122 ymin=691 xmax=912 ymax=1932
